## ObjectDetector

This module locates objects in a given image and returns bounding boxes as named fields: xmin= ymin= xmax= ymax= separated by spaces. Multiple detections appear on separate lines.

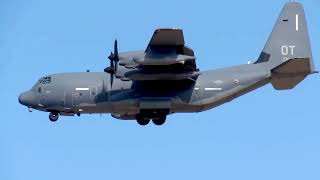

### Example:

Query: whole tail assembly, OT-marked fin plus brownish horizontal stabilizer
xmin=255 ymin=2 xmax=315 ymax=90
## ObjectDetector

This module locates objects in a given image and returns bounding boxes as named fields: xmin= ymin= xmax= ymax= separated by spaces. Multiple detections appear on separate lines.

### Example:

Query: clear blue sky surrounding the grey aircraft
xmin=0 ymin=0 xmax=320 ymax=180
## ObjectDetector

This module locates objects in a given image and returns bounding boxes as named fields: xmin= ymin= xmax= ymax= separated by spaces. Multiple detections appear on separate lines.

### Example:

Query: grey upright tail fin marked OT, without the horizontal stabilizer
xmin=256 ymin=2 xmax=314 ymax=72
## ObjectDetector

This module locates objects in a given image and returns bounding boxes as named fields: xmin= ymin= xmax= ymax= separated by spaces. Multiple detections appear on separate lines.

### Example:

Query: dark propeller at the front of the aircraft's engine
xmin=104 ymin=39 xmax=119 ymax=87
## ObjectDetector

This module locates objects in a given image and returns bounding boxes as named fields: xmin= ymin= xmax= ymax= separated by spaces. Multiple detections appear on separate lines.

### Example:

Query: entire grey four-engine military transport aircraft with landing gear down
xmin=19 ymin=2 xmax=316 ymax=125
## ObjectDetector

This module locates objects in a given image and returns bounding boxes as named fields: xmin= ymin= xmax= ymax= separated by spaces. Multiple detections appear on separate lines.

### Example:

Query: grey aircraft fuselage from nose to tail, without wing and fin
xmin=19 ymin=64 xmax=270 ymax=119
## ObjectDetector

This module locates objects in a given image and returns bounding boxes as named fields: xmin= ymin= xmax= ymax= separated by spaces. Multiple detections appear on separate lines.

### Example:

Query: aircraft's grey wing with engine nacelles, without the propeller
xmin=117 ymin=29 xmax=198 ymax=81
